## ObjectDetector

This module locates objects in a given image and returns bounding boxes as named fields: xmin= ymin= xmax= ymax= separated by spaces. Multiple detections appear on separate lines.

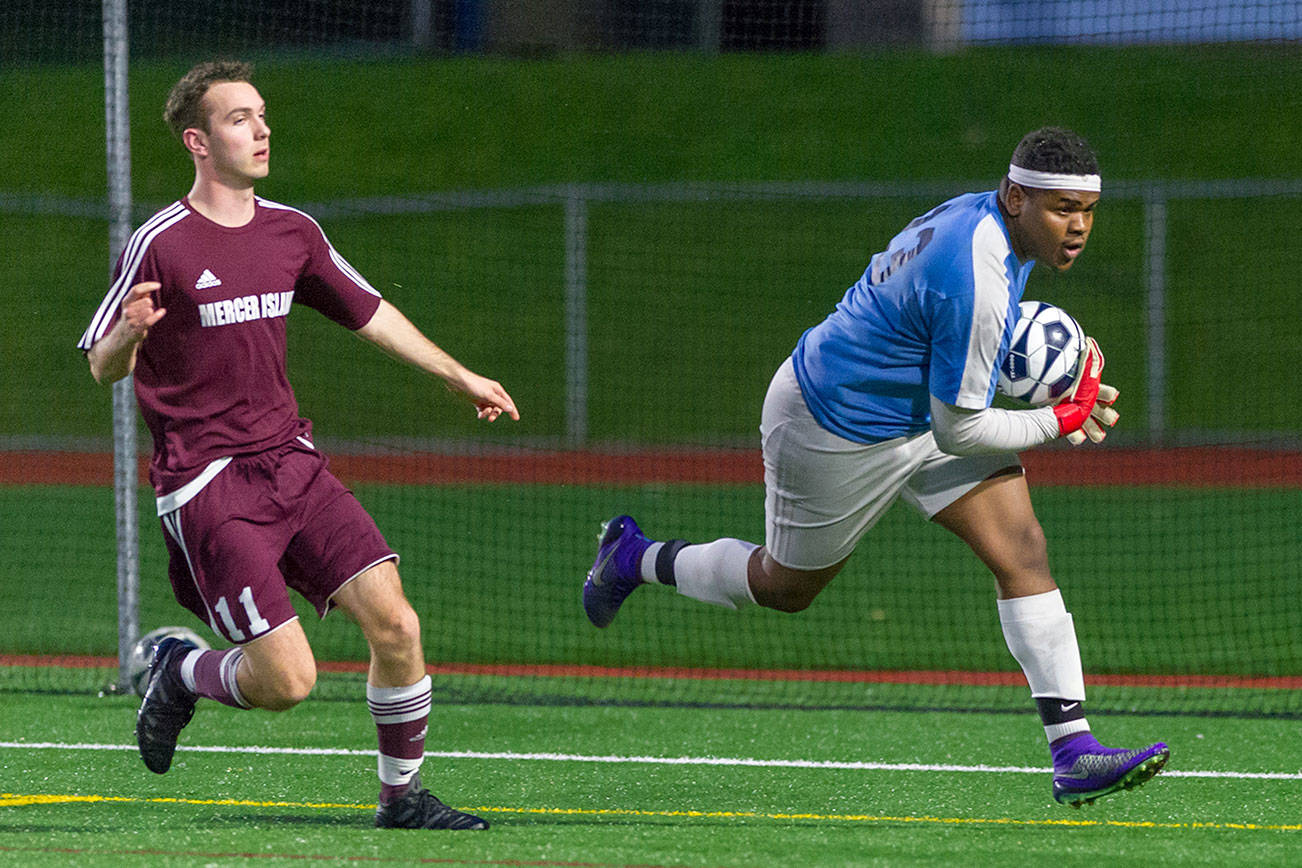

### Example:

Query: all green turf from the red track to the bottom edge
xmin=0 ymin=485 xmax=1302 ymax=865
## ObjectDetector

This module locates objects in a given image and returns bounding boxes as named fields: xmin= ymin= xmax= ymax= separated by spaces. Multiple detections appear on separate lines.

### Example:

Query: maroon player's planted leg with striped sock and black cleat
xmin=335 ymin=561 xmax=488 ymax=829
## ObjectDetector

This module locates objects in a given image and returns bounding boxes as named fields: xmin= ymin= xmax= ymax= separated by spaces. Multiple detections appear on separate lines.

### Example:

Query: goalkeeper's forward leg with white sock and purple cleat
xmin=935 ymin=474 xmax=1170 ymax=807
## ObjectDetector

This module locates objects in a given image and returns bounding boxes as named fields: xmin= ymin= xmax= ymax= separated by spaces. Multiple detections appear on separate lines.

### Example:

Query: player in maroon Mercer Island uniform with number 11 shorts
xmin=79 ymin=62 xmax=519 ymax=829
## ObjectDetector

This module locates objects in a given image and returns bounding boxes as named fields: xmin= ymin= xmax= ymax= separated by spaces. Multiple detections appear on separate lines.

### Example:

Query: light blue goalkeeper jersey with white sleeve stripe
xmin=792 ymin=190 xmax=1035 ymax=442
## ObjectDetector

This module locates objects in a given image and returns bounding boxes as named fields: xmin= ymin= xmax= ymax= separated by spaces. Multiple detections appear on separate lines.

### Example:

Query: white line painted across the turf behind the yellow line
xmin=0 ymin=742 xmax=1302 ymax=781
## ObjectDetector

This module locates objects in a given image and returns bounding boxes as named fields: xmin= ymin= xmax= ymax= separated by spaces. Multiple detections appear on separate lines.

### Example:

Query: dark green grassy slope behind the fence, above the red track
xmin=0 ymin=47 xmax=1302 ymax=442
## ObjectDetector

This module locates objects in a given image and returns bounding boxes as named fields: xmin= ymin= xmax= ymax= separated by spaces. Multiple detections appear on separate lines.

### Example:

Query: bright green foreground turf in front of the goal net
xmin=0 ymin=692 xmax=1302 ymax=865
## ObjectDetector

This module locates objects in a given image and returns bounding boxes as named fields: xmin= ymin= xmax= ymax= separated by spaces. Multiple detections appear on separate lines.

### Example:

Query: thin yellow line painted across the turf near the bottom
xmin=0 ymin=793 xmax=1302 ymax=832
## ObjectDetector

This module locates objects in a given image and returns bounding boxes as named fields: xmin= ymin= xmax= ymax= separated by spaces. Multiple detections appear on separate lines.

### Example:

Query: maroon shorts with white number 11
xmin=163 ymin=440 xmax=397 ymax=644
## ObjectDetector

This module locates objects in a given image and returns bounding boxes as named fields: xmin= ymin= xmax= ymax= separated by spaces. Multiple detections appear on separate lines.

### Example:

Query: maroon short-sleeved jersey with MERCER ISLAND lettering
xmin=78 ymin=198 xmax=380 ymax=497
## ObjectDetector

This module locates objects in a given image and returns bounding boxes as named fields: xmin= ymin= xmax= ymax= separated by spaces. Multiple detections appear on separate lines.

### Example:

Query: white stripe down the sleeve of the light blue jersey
xmin=954 ymin=215 xmax=1013 ymax=410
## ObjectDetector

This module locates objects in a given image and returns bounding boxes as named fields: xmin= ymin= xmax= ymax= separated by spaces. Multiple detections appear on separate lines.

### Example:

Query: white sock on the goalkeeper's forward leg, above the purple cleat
xmin=997 ymin=588 xmax=1090 ymax=742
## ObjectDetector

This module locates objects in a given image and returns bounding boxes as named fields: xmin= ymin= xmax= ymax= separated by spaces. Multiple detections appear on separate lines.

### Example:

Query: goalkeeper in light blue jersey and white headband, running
xmin=583 ymin=128 xmax=1169 ymax=806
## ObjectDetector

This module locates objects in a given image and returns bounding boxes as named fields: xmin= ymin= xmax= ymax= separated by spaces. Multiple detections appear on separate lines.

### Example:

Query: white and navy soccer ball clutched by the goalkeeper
xmin=996 ymin=302 xmax=1085 ymax=407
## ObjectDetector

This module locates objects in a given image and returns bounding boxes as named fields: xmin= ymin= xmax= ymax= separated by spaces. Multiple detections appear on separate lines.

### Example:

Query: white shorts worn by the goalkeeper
xmin=759 ymin=358 xmax=1021 ymax=570
